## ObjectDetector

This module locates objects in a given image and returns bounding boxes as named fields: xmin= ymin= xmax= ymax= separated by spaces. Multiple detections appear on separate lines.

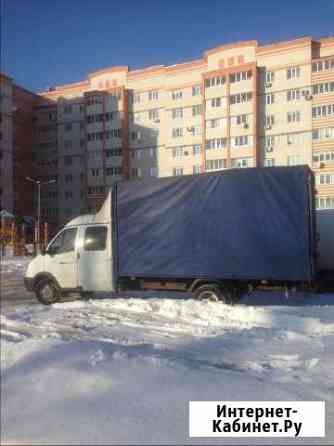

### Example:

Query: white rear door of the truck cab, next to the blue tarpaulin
xmin=78 ymin=224 xmax=113 ymax=292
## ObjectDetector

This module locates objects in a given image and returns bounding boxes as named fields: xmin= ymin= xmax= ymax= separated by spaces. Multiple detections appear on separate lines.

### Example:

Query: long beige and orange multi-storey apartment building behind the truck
xmin=29 ymin=37 xmax=334 ymax=224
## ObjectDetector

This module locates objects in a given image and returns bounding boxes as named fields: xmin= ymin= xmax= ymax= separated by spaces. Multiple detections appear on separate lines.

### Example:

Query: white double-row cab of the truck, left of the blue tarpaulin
xmin=24 ymin=193 xmax=114 ymax=304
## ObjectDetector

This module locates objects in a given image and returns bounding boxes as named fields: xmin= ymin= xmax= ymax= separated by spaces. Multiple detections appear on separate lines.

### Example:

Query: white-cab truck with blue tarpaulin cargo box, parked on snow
xmin=25 ymin=166 xmax=334 ymax=304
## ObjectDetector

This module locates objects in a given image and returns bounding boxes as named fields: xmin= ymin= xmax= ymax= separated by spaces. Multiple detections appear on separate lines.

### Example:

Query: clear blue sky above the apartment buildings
xmin=0 ymin=0 xmax=334 ymax=91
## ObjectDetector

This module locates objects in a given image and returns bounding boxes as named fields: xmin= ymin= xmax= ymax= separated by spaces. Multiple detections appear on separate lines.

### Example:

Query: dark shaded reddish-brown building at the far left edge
xmin=0 ymin=73 xmax=38 ymax=216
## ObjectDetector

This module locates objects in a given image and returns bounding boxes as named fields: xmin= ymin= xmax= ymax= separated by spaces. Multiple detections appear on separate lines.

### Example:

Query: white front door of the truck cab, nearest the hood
xmin=45 ymin=228 xmax=78 ymax=289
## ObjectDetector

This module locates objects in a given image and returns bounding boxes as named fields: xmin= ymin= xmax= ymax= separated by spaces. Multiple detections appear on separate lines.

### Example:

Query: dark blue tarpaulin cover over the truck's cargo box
xmin=114 ymin=166 xmax=314 ymax=281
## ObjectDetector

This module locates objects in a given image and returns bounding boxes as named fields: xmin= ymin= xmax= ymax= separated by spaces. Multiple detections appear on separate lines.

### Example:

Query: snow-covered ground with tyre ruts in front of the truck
xmin=1 ymin=258 xmax=334 ymax=444
